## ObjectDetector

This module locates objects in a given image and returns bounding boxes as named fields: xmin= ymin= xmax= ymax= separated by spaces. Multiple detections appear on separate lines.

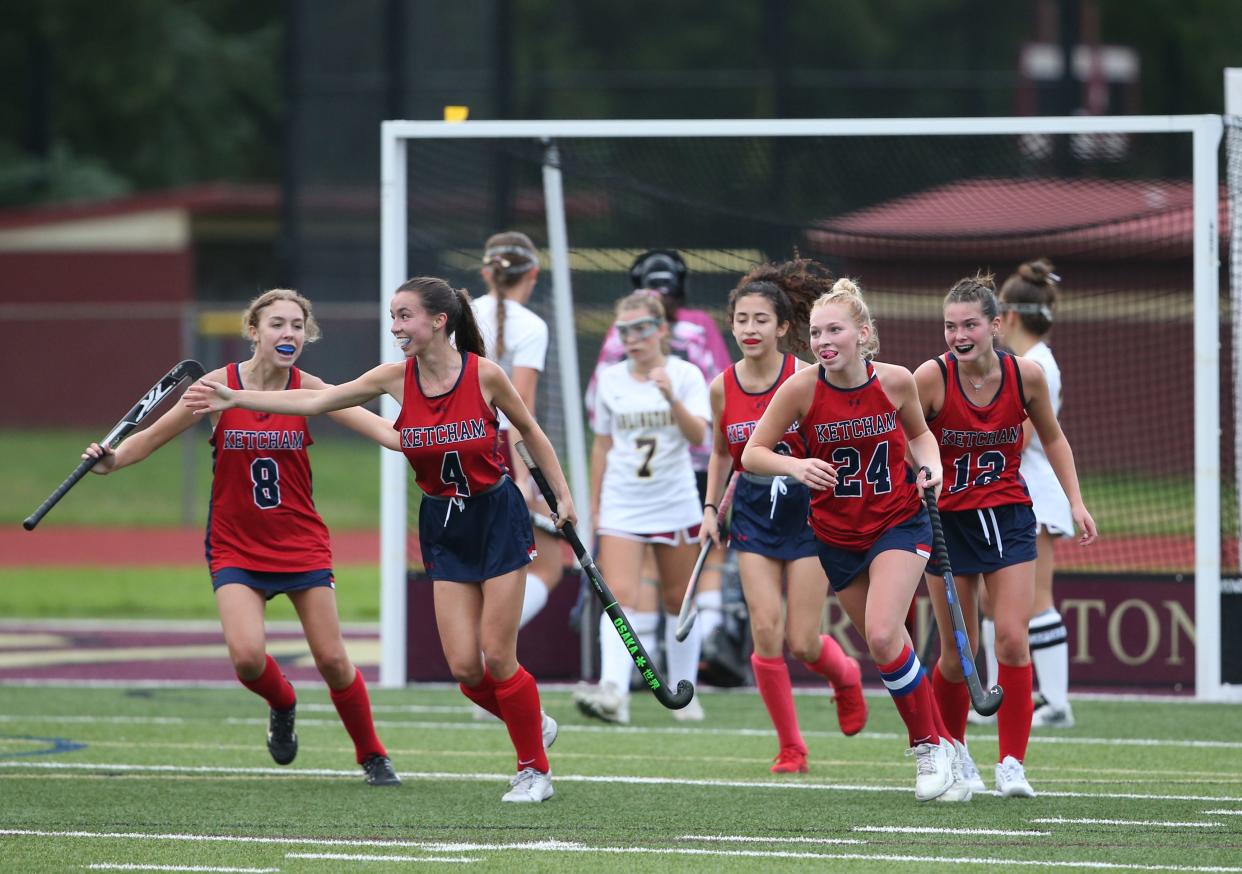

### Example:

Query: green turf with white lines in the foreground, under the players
xmin=0 ymin=684 xmax=1242 ymax=874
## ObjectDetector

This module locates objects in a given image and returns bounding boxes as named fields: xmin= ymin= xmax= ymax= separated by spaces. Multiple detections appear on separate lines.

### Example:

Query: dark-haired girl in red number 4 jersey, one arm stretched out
xmin=186 ymin=277 xmax=576 ymax=802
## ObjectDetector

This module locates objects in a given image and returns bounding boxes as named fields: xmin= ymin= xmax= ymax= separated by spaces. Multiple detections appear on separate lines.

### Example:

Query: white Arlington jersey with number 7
xmin=595 ymin=356 xmax=712 ymax=534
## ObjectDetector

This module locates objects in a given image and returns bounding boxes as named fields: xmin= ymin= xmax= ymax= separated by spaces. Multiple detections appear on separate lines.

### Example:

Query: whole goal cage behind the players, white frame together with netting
xmin=379 ymin=115 xmax=1242 ymax=700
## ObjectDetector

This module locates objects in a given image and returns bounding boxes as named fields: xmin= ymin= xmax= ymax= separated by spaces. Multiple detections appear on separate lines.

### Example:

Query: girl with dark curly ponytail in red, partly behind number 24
xmin=702 ymin=258 xmax=867 ymax=773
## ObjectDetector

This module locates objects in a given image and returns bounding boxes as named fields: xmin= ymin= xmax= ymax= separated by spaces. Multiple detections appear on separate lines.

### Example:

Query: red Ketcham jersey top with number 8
xmin=206 ymin=364 xmax=332 ymax=574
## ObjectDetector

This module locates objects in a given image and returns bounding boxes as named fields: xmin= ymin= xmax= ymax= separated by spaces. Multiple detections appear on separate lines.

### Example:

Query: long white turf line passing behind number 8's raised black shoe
xmin=0 ymin=708 xmax=1242 ymax=750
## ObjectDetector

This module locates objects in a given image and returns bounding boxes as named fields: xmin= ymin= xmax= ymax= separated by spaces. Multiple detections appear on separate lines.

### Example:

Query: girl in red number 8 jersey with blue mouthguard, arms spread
xmin=86 ymin=288 xmax=401 ymax=786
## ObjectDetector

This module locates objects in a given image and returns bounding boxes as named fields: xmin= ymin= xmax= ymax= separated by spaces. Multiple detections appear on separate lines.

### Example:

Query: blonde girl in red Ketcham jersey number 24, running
xmin=741 ymin=279 xmax=956 ymax=801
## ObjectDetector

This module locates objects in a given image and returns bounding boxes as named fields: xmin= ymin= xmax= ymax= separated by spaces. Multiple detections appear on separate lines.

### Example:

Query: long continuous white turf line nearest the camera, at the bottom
xmin=9 ymin=829 xmax=1242 ymax=874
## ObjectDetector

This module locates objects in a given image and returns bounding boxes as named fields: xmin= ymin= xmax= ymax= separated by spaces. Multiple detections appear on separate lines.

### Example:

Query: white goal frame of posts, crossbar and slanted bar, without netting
xmin=379 ymin=115 xmax=1242 ymax=700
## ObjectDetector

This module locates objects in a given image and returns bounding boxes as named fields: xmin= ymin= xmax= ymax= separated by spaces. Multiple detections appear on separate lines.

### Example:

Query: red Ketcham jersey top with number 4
xmin=392 ymin=353 xmax=507 ymax=498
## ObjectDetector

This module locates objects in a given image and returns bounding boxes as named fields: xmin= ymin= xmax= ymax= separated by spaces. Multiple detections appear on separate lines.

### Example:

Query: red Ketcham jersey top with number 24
xmin=802 ymin=363 xmax=919 ymax=550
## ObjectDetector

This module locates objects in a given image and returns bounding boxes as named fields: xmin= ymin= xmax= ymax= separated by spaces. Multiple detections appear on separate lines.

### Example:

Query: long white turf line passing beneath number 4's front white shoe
xmin=0 ymin=760 xmax=1242 ymax=804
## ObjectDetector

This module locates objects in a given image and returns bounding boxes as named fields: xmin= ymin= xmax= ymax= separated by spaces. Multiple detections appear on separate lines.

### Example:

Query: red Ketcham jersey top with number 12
xmin=928 ymin=351 xmax=1031 ymax=510
